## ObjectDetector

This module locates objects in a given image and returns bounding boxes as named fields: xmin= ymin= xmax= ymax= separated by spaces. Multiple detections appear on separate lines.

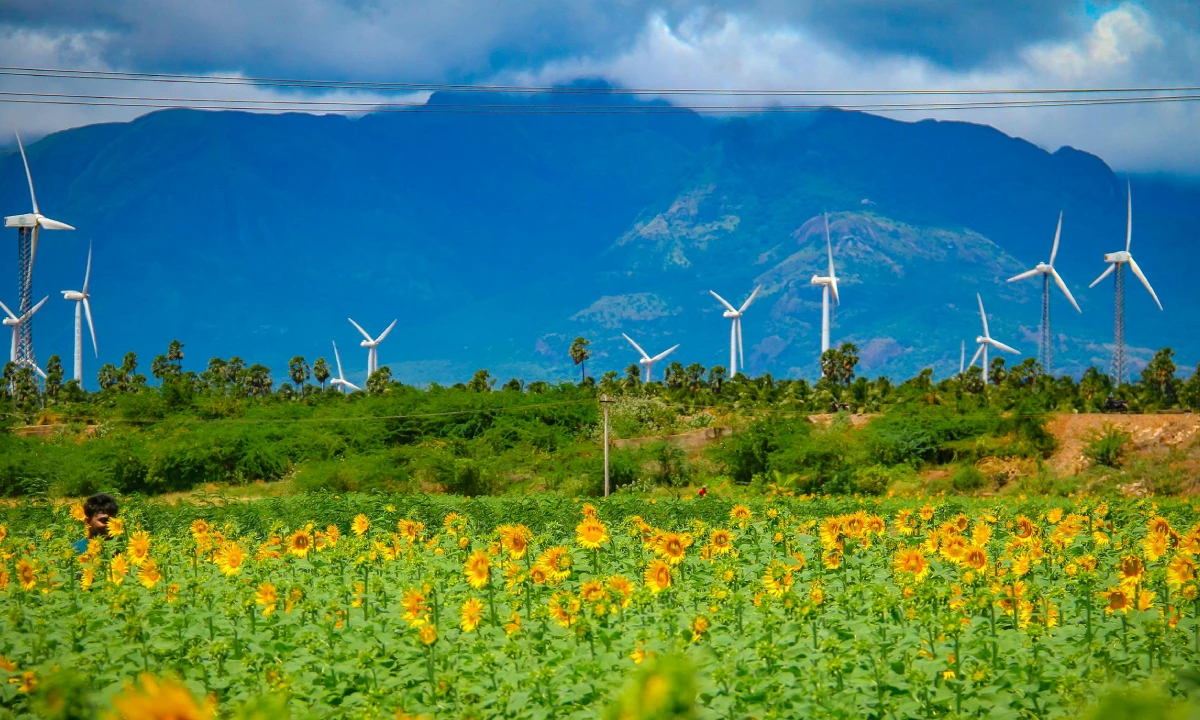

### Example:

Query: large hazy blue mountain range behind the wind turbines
xmin=0 ymin=87 xmax=1200 ymax=386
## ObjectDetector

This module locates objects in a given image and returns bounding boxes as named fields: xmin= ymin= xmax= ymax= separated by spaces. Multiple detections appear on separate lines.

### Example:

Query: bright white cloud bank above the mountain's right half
xmin=516 ymin=5 xmax=1200 ymax=173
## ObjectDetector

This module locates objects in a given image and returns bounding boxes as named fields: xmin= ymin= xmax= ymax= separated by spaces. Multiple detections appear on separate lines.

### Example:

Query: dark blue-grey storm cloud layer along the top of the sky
xmin=0 ymin=0 xmax=1104 ymax=79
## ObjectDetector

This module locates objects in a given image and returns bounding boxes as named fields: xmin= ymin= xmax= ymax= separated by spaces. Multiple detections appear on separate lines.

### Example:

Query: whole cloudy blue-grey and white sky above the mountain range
xmin=0 ymin=0 xmax=1200 ymax=175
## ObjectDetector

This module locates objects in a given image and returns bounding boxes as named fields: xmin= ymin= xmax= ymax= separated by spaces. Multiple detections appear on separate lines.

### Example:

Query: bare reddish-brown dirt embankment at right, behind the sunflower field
xmin=1046 ymin=413 xmax=1200 ymax=475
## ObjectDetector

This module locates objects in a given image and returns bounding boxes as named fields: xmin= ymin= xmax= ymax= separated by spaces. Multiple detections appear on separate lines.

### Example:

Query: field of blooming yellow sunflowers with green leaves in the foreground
xmin=0 ymin=496 xmax=1200 ymax=720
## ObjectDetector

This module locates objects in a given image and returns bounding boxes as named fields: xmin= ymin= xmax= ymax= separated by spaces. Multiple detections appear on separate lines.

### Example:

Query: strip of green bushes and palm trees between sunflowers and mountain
xmin=0 ymin=342 xmax=1200 ymax=497
